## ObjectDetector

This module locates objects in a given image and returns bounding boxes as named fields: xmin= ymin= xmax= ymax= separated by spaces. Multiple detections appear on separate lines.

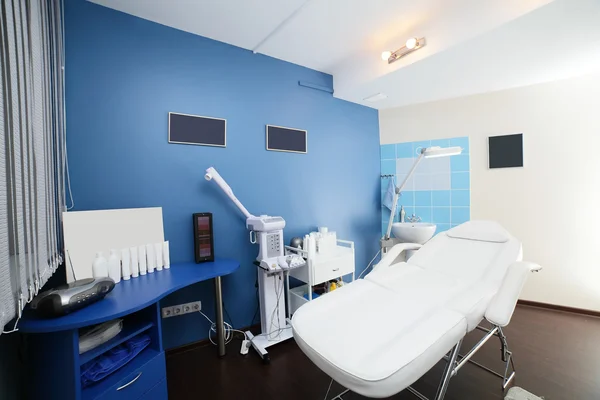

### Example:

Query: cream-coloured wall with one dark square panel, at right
xmin=379 ymin=74 xmax=600 ymax=310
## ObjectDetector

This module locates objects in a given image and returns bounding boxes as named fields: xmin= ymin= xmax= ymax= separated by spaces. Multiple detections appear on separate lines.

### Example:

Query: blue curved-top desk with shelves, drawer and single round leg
xmin=19 ymin=259 xmax=240 ymax=400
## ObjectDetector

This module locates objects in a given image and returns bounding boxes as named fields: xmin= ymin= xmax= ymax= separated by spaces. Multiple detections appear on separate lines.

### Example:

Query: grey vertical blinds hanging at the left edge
xmin=0 ymin=0 xmax=66 ymax=327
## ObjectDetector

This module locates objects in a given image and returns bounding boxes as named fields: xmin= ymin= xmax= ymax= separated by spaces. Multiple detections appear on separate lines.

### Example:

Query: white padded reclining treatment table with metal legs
xmin=292 ymin=221 xmax=541 ymax=400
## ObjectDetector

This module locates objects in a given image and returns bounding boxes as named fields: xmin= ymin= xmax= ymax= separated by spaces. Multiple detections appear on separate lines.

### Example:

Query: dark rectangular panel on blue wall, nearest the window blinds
xmin=169 ymin=112 xmax=227 ymax=147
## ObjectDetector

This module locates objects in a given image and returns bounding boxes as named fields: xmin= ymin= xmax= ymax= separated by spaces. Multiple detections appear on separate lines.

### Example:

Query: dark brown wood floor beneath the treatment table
xmin=167 ymin=306 xmax=600 ymax=400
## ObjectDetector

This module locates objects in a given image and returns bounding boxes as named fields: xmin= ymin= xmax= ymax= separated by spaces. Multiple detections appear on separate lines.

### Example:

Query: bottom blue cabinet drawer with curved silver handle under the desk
xmin=98 ymin=349 xmax=167 ymax=400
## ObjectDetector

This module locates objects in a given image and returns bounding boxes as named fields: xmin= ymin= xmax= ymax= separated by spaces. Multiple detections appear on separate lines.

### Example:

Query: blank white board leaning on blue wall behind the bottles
xmin=62 ymin=207 xmax=165 ymax=283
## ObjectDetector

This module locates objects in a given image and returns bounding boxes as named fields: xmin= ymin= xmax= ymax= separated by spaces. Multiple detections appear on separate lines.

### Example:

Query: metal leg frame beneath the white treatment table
xmin=325 ymin=325 xmax=516 ymax=400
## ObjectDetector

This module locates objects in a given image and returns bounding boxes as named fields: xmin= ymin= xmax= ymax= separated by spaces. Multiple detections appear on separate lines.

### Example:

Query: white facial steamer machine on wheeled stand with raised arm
xmin=204 ymin=167 xmax=305 ymax=362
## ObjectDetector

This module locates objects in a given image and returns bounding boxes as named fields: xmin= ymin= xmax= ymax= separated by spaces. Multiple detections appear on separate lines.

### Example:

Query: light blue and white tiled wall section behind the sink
xmin=381 ymin=137 xmax=471 ymax=238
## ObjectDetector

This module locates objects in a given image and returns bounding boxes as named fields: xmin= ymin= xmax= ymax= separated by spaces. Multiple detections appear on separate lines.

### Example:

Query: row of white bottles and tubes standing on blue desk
xmin=92 ymin=241 xmax=171 ymax=283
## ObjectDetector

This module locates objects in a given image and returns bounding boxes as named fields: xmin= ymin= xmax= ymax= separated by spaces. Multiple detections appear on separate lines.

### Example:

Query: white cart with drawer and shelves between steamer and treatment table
xmin=285 ymin=239 xmax=355 ymax=315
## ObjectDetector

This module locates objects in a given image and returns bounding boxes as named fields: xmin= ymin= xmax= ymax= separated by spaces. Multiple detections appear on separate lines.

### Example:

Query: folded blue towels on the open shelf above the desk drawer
xmin=81 ymin=334 xmax=150 ymax=388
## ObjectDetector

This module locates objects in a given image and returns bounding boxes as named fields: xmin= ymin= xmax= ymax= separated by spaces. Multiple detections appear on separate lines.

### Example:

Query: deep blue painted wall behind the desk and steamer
xmin=65 ymin=0 xmax=380 ymax=347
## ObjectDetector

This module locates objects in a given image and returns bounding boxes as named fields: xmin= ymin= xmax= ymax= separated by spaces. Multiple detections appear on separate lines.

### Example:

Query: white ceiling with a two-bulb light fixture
xmin=91 ymin=0 xmax=600 ymax=109
